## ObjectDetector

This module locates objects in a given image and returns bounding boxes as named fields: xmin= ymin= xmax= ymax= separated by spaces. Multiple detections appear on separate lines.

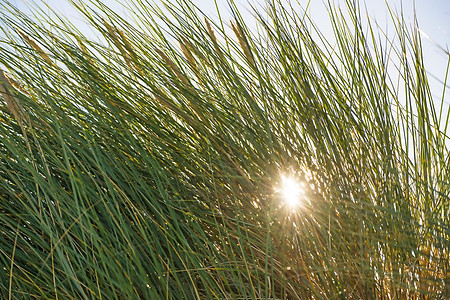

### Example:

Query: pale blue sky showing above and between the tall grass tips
xmin=6 ymin=0 xmax=450 ymax=104
